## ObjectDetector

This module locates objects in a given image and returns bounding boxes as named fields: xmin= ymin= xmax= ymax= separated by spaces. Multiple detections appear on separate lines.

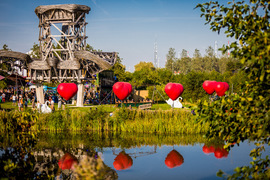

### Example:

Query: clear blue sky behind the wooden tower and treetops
xmin=0 ymin=0 xmax=232 ymax=72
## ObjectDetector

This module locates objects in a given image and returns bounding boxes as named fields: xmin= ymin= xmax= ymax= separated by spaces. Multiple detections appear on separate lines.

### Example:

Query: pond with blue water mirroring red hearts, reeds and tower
xmin=0 ymin=132 xmax=270 ymax=180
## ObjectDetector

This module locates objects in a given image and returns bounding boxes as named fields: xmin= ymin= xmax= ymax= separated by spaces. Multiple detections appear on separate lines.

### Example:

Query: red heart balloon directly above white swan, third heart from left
xmin=164 ymin=83 xmax=184 ymax=101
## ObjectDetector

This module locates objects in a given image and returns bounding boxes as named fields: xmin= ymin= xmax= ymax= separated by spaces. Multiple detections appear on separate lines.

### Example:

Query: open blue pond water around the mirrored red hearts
xmin=103 ymin=142 xmax=254 ymax=180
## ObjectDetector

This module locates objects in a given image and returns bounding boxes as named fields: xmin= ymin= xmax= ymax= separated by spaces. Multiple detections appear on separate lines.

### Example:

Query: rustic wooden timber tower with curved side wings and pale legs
xmin=0 ymin=4 xmax=117 ymax=106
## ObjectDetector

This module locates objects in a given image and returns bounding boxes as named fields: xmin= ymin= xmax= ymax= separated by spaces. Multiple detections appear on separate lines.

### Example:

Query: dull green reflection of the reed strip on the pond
xmin=35 ymin=131 xmax=206 ymax=151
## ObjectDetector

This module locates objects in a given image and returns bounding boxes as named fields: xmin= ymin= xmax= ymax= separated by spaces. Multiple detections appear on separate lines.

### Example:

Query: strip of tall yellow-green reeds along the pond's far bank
xmin=0 ymin=101 xmax=205 ymax=134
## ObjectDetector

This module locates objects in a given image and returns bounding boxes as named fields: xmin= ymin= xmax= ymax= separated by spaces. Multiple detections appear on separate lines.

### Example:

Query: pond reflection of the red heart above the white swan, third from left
xmin=165 ymin=150 xmax=184 ymax=168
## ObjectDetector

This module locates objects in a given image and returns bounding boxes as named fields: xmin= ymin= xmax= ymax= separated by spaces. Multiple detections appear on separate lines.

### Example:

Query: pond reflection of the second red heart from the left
xmin=113 ymin=152 xmax=133 ymax=171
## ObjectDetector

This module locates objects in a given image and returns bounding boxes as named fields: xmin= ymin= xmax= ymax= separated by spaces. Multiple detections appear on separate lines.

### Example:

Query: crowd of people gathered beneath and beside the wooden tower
xmin=0 ymin=86 xmax=150 ymax=111
